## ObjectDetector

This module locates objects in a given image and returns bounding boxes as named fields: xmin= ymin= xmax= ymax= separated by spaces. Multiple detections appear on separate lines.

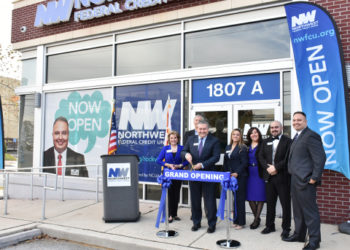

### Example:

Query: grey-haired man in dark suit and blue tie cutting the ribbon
xmin=181 ymin=120 xmax=220 ymax=233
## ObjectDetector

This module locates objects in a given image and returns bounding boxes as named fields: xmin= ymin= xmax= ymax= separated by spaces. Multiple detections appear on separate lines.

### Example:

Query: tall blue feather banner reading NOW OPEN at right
xmin=285 ymin=2 xmax=350 ymax=179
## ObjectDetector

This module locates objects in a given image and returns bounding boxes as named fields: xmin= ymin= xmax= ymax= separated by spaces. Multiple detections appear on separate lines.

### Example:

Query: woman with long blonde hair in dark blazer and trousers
xmin=224 ymin=129 xmax=248 ymax=229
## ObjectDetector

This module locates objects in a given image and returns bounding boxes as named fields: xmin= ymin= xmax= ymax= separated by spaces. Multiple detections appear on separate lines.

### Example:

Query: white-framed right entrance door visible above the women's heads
xmin=233 ymin=102 xmax=281 ymax=140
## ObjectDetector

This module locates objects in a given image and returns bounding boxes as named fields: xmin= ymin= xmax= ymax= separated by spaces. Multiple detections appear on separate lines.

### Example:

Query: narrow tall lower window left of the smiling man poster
xmin=18 ymin=95 xmax=34 ymax=168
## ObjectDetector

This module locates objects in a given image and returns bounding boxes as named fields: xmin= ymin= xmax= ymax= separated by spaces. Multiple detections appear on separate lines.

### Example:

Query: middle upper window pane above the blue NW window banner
xmin=116 ymin=36 xmax=181 ymax=75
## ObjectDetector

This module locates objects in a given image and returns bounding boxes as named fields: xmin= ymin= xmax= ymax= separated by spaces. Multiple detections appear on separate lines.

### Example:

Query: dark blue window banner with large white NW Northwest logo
xmin=115 ymin=82 xmax=181 ymax=182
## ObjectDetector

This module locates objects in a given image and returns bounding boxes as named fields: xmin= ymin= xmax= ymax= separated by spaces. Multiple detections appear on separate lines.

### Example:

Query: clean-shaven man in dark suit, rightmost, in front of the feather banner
xmin=285 ymin=111 xmax=326 ymax=250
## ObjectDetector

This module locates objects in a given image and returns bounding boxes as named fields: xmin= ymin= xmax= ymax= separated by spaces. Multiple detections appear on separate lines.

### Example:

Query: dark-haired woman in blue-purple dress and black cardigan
xmin=246 ymin=127 xmax=266 ymax=229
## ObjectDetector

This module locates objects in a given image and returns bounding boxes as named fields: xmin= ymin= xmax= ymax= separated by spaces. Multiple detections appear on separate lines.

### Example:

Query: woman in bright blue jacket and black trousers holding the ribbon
xmin=157 ymin=131 xmax=188 ymax=223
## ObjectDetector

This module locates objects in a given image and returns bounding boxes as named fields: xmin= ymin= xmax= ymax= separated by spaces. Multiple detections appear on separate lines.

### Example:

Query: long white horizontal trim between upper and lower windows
xmin=16 ymin=59 xmax=293 ymax=95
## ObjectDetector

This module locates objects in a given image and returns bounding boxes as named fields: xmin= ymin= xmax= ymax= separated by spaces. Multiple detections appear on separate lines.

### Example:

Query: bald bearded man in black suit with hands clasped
xmin=258 ymin=121 xmax=292 ymax=239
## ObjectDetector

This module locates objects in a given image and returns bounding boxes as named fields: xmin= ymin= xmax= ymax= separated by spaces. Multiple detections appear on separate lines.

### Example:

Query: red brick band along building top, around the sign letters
xmin=11 ymin=0 xmax=222 ymax=43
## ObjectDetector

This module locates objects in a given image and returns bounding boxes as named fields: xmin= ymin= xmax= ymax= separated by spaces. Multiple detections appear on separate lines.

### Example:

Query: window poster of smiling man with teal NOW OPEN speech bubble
xmin=43 ymin=89 xmax=112 ymax=177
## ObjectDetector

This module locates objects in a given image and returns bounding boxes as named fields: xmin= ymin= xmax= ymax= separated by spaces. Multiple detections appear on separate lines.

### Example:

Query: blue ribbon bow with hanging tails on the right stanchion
xmin=216 ymin=176 xmax=238 ymax=220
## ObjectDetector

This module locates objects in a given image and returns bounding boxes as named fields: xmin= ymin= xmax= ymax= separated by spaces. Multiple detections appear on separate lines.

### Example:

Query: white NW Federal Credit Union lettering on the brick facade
xmin=34 ymin=0 xmax=168 ymax=27
